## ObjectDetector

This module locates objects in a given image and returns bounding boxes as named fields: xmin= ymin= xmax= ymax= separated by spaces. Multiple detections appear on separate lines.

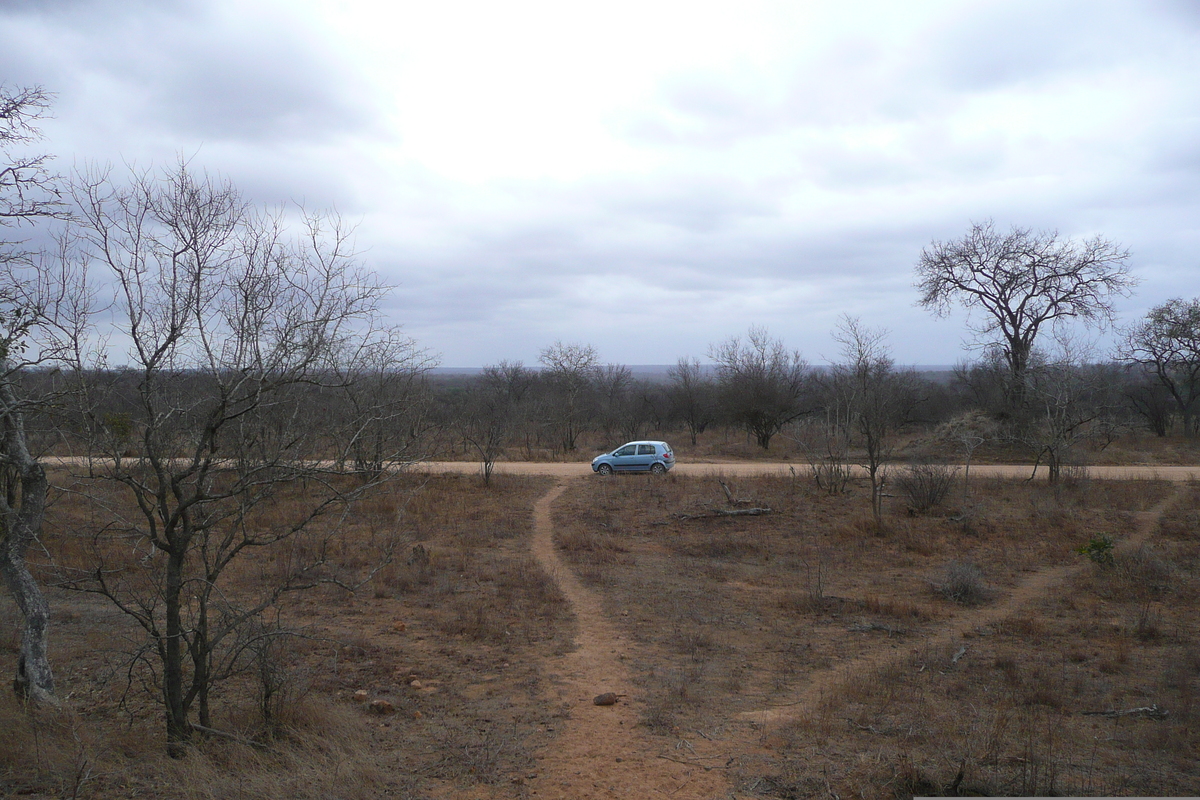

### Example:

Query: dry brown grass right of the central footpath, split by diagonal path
xmin=556 ymin=476 xmax=1200 ymax=798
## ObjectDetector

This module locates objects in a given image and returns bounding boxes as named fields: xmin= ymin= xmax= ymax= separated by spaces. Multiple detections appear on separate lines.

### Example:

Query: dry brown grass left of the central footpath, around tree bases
xmin=0 ymin=476 xmax=571 ymax=799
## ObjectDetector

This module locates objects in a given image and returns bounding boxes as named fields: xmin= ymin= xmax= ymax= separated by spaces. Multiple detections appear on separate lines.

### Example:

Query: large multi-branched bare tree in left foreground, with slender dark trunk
xmin=59 ymin=163 xmax=419 ymax=754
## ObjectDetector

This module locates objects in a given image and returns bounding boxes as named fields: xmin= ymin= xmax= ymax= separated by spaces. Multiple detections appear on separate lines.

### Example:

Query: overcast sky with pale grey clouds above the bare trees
xmin=0 ymin=0 xmax=1200 ymax=366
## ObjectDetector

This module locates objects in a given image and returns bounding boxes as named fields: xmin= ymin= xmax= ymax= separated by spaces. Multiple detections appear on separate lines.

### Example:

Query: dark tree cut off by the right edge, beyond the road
xmin=1121 ymin=297 xmax=1200 ymax=435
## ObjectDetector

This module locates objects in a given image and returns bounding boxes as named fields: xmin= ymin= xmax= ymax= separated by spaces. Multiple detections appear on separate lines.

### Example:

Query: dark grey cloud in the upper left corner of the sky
xmin=1 ymin=0 xmax=372 ymax=145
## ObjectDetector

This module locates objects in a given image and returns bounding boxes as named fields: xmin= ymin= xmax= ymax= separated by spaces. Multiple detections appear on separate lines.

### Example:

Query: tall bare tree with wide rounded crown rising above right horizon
xmin=916 ymin=221 xmax=1135 ymax=408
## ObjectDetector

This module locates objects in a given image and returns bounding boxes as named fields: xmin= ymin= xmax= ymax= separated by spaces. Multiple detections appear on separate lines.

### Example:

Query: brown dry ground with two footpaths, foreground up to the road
xmin=0 ymin=462 xmax=1200 ymax=800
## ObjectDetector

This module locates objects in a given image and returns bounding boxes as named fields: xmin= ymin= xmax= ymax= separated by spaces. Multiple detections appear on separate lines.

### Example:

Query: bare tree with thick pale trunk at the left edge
xmin=0 ymin=86 xmax=75 ymax=704
